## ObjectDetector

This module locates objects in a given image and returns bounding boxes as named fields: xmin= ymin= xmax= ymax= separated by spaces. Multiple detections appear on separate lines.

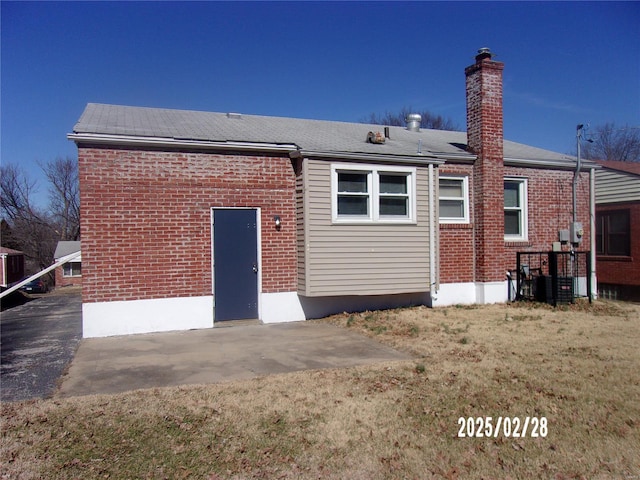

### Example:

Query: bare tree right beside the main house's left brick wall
xmin=41 ymin=157 xmax=80 ymax=240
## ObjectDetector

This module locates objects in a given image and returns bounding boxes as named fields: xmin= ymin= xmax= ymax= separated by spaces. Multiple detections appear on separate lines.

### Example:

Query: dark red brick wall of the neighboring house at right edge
xmin=596 ymin=202 xmax=640 ymax=286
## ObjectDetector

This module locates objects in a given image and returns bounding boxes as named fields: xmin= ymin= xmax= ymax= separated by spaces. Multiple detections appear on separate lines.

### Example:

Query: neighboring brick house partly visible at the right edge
xmin=596 ymin=161 xmax=640 ymax=300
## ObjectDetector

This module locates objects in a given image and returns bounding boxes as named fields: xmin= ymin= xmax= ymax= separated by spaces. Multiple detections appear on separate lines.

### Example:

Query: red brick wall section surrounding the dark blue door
xmin=78 ymin=146 xmax=297 ymax=302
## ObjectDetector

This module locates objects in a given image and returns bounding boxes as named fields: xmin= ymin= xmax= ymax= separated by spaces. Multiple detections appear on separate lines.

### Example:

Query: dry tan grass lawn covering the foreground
xmin=0 ymin=302 xmax=640 ymax=479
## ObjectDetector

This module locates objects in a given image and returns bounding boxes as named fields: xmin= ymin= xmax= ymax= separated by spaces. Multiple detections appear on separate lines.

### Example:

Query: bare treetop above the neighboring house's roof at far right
xmin=582 ymin=123 xmax=640 ymax=162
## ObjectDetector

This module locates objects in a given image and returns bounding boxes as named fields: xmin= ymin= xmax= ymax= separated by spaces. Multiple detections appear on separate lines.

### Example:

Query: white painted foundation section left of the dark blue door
xmin=82 ymin=296 xmax=213 ymax=338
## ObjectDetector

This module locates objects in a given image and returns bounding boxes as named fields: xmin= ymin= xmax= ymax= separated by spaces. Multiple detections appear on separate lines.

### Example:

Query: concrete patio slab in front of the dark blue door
xmin=56 ymin=321 xmax=412 ymax=397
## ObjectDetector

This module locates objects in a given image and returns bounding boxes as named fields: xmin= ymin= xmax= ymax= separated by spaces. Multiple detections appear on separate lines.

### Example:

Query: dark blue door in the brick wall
xmin=213 ymin=209 xmax=258 ymax=321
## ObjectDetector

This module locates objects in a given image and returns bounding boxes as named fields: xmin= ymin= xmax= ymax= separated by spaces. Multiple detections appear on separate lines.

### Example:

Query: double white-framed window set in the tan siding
xmin=331 ymin=164 xmax=416 ymax=223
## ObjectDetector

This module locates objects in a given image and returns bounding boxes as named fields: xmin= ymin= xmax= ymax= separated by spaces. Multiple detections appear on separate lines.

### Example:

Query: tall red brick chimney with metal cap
xmin=465 ymin=48 xmax=505 ymax=288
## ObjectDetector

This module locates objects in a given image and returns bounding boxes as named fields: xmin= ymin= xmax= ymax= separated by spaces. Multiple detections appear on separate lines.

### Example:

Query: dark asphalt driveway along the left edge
xmin=0 ymin=290 xmax=82 ymax=401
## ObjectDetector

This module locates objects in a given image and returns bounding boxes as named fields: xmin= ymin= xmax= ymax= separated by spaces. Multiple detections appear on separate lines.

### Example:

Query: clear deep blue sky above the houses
xmin=0 ymin=1 xmax=640 ymax=208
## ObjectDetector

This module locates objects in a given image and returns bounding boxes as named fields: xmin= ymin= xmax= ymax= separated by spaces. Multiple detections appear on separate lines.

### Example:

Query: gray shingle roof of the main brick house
xmin=69 ymin=103 xmax=575 ymax=166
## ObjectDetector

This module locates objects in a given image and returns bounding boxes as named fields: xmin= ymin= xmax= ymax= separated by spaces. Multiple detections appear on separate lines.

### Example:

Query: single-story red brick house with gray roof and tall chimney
xmin=68 ymin=50 xmax=595 ymax=337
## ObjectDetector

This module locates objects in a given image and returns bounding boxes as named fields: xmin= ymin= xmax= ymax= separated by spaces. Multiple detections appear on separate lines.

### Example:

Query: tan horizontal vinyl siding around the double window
xmin=299 ymin=160 xmax=429 ymax=296
